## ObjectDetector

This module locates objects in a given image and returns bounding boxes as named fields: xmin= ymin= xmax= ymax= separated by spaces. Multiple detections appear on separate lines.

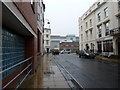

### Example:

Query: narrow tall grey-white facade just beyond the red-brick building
xmin=37 ymin=0 xmax=45 ymax=55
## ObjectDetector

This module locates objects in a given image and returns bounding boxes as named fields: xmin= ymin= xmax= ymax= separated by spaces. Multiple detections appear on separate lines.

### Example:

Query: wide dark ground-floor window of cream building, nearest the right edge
xmin=103 ymin=40 xmax=113 ymax=52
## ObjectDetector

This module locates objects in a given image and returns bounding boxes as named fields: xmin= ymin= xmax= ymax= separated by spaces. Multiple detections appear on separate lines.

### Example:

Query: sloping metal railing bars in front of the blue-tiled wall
xmin=0 ymin=57 xmax=33 ymax=89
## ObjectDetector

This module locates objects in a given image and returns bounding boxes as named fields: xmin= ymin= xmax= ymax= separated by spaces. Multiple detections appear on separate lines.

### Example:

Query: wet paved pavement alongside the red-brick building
xmin=21 ymin=54 xmax=70 ymax=90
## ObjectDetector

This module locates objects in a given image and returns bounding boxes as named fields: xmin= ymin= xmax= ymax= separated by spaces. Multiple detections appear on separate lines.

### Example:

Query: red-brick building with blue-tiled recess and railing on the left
xmin=0 ymin=0 xmax=45 ymax=89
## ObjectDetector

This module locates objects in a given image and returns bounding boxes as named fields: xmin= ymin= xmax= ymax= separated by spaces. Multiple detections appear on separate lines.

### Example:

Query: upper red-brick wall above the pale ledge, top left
xmin=14 ymin=2 xmax=37 ymax=33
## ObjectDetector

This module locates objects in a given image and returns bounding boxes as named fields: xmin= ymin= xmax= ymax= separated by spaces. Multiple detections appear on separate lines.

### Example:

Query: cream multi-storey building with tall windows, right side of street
xmin=79 ymin=0 xmax=119 ymax=56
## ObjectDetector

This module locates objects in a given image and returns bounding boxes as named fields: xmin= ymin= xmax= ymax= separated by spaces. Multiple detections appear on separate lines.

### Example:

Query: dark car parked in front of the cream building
xmin=79 ymin=50 xmax=95 ymax=58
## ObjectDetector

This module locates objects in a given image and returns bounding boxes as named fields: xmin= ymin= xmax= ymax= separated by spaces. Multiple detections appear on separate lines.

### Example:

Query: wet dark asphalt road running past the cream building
xmin=54 ymin=54 xmax=120 ymax=88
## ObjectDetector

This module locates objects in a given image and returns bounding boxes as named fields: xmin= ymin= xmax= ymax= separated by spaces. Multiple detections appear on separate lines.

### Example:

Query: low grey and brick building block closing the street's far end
xmin=51 ymin=35 xmax=79 ymax=52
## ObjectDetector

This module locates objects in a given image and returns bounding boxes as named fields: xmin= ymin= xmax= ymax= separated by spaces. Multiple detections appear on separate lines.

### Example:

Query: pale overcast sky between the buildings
xmin=44 ymin=0 xmax=96 ymax=35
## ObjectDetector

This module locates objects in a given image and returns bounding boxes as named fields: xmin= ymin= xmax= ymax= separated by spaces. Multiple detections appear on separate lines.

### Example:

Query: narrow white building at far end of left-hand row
xmin=44 ymin=28 xmax=51 ymax=53
